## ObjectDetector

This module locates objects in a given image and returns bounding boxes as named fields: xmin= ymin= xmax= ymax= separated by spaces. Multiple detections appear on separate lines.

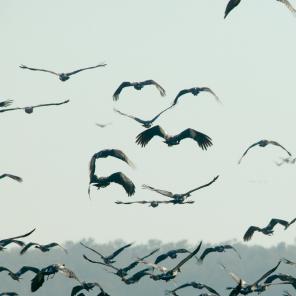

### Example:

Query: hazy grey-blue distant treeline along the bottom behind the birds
xmin=0 ymin=239 xmax=296 ymax=296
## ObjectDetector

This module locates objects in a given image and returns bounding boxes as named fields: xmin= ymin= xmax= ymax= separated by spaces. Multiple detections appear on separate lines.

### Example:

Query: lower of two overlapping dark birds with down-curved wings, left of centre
xmin=88 ymin=172 xmax=136 ymax=196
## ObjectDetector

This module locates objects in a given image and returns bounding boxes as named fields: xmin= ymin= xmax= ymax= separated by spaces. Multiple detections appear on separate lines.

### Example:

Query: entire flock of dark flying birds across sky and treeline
xmin=0 ymin=0 xmax=296 ymax=296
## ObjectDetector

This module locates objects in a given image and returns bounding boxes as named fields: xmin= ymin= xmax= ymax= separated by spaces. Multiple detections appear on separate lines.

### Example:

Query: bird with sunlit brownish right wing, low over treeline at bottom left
xmin=31 ymin=264 xmax=81 ymax=292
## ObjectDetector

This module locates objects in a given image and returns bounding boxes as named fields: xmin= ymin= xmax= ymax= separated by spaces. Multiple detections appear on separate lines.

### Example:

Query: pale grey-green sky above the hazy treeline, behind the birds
xmin=0 ymin=0 xmax=296 ymax=246
